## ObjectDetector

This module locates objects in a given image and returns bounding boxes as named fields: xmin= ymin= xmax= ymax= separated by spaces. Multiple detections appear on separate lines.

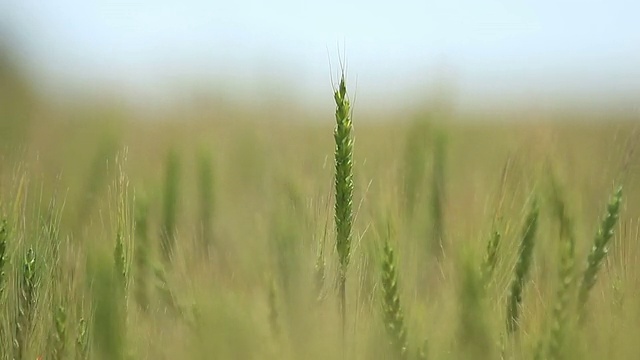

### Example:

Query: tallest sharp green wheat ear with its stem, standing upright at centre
xmin=334 ymin=74 xmax=353 ymax=337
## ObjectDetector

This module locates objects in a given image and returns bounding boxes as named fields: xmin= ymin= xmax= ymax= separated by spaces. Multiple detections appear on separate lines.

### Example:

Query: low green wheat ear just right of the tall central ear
xmin=381 ymin=239 xmax=407 ymax=359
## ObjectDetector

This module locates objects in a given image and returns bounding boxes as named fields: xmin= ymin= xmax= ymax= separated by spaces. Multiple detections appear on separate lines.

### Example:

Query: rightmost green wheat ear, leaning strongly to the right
xmin=578 ymin=186 xmax=622 ymax=318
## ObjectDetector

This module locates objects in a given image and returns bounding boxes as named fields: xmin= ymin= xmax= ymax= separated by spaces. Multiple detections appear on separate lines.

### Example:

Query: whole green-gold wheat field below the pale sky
xmin=0 ymin=71 xmax=640 ymax=360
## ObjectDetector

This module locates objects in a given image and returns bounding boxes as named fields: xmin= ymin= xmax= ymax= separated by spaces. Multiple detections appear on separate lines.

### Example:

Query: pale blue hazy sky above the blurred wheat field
xmin=0 ymin=0 xmax=640 ymax=109
